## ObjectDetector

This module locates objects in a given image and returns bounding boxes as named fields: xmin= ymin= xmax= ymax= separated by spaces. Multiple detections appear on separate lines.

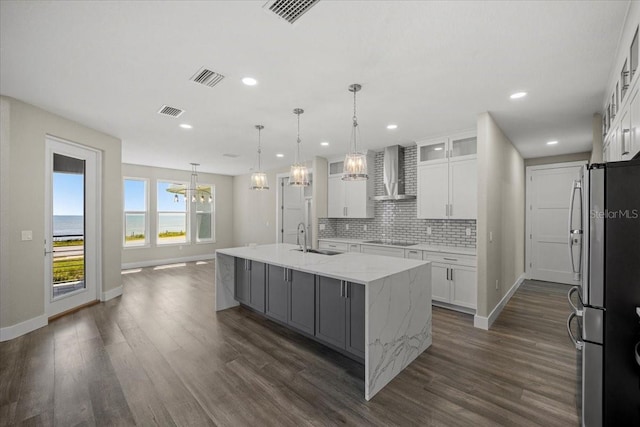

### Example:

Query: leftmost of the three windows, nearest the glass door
xmin=123 ymin=178 xmax=149 ymax=247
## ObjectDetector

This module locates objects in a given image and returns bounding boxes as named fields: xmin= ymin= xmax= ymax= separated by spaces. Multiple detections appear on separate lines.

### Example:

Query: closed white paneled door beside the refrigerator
xmin=527 ymin=163 xmax=582 ymax=284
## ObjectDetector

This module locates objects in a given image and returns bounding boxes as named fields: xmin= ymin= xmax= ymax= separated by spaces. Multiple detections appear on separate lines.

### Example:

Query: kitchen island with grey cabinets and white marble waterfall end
xmin=216 ymin=244 xmax=432 ymax=400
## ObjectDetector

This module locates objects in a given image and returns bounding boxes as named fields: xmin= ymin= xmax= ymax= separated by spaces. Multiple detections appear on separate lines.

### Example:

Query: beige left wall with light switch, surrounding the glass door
xmin=0 ymin=97 xmax=122 ymax=328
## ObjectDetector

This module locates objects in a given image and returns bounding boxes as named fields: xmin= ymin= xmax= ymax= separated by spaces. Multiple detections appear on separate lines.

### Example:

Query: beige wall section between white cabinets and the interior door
xmin=477 ymin=113 xmax=525 ymax=317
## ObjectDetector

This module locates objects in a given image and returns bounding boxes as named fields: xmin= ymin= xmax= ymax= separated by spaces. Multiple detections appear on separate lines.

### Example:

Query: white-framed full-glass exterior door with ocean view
xmin=44 ymin=137 xmax=100 ymax=317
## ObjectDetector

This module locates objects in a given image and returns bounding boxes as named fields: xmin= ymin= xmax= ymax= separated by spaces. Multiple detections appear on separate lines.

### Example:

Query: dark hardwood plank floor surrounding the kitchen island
xmin=0 ymin=262 xmax=578 ymax=426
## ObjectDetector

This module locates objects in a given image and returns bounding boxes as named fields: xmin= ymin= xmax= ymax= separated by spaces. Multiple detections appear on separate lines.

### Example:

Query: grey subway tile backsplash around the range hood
xmin=317 ymin=145 xmax=476 ymax=248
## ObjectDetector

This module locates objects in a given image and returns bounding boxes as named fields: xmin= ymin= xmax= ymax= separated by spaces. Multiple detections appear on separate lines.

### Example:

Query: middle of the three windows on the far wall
xmin=157 ymin=181 xmax=189 ymax=245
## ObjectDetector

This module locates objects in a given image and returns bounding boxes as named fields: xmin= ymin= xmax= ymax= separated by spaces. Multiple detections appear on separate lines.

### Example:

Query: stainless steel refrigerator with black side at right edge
xmin=567 ymin=160 xmax=640 ymax=427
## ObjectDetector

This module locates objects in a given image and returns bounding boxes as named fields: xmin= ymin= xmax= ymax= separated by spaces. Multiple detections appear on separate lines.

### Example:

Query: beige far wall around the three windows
xmin=122 ymin=163 xmax=233 ymax=267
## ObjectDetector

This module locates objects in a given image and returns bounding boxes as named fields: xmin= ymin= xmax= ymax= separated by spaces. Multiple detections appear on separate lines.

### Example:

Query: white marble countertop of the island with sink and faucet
xmin=216 ymin=243 xmax=428 ymax=285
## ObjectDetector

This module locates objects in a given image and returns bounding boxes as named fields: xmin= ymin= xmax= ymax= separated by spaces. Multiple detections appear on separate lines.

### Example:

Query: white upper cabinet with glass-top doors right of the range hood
xmin=417 ymin=131 xmax=478 ymax=219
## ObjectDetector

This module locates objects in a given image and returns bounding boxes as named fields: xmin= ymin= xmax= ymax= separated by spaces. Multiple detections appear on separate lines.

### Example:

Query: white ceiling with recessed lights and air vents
xmin=0 ymin=0 xmax=629 ymax=175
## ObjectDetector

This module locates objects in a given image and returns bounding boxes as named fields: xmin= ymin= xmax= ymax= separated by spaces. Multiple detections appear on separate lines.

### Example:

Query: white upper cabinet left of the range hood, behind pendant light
xmin=327 ymin=152 xmax=375 ymax=218
